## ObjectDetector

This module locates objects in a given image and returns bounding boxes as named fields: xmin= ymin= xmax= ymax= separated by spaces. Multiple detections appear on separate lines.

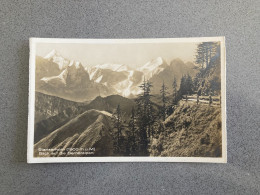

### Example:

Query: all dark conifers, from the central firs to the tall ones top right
xmin=113 ymin=42 xmax=219 ymax=156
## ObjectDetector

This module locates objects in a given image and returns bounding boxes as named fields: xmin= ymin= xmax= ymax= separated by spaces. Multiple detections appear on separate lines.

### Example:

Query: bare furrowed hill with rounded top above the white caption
xmin=34 ymin=110 xmax=113 ymax=156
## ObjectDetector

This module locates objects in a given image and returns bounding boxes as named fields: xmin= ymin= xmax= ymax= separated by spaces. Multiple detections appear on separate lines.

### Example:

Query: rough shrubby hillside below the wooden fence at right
xmin=151 ymin=102 xmax=222 ymax=157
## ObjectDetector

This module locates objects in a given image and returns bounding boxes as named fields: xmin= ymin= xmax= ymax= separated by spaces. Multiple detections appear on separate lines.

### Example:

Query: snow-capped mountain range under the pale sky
xmin=36 ymin=50 xmax=197 ymax=102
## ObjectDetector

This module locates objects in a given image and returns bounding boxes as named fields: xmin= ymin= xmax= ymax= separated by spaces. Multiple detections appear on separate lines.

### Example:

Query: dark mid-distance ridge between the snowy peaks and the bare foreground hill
xmin=34 ymin=92 xmax=136 ymax=143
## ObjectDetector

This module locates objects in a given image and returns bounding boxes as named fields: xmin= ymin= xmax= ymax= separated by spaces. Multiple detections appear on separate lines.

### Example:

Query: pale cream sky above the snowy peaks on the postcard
xmin=36 ymin=42 xmax=198 ymax=68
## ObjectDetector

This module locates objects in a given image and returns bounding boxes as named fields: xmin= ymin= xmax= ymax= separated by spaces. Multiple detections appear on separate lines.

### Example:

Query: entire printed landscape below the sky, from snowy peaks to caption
xmin=34 ymin=43 xmax=222 ymax=157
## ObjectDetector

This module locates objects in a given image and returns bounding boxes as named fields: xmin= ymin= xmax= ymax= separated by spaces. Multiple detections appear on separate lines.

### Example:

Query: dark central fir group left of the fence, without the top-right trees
xmin=113 ymin=75 xmax=197 ymax=156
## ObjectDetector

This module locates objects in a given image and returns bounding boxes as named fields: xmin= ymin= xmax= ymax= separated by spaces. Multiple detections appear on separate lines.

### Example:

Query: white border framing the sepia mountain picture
xmin=27 ymin=37 xmax=227 ymax=163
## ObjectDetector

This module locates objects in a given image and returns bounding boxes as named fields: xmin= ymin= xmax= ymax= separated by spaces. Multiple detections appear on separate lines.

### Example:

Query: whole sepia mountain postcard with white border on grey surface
xmin=27 ymin=37 xmax=227 ymax=163
